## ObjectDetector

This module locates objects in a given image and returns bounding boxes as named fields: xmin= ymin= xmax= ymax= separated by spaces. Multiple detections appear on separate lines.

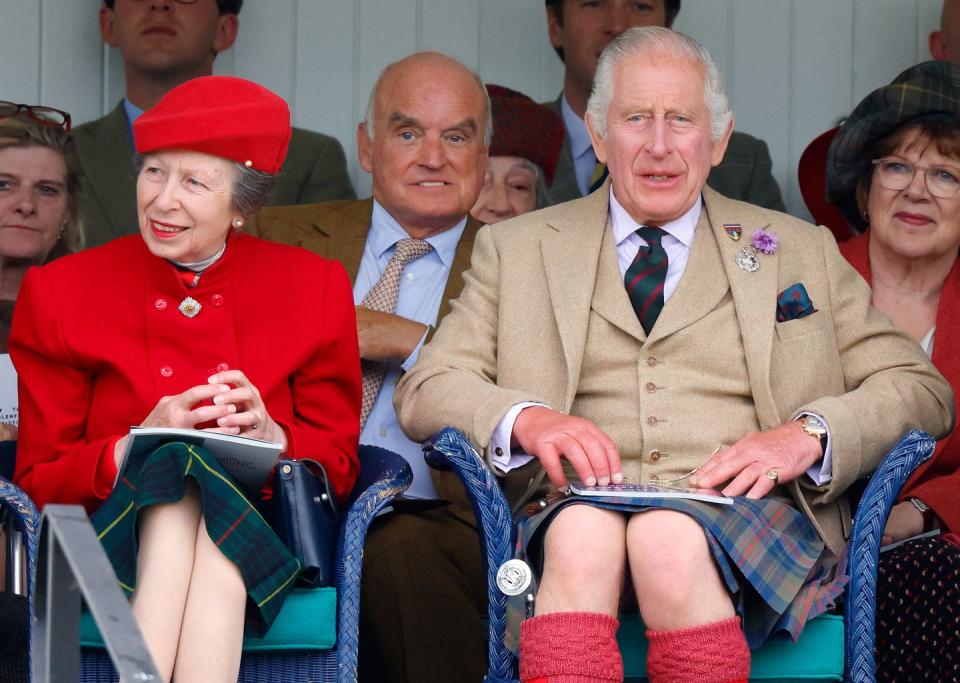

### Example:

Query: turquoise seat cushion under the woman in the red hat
xmin=80 ymin=588 xmax=337 ymax=652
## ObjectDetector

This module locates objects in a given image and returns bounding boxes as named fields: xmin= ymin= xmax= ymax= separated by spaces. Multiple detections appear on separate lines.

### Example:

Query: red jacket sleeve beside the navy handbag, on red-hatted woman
xmin=278 ymin=261 xmax=360 ymax=500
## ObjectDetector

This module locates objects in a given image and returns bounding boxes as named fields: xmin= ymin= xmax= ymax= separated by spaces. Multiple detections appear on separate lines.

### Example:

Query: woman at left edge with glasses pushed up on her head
xmin=0 ymin=101 xmax=83 ymax=444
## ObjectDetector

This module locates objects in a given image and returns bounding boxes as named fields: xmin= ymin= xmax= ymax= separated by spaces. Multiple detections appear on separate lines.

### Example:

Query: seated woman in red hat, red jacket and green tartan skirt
xmin=10 ymin=76 xmax=360 ymax=681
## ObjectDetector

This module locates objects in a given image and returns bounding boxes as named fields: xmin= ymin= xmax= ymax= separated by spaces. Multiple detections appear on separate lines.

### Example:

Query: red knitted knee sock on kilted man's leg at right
xmin=647 ymin=617 xmax=750 ymax=683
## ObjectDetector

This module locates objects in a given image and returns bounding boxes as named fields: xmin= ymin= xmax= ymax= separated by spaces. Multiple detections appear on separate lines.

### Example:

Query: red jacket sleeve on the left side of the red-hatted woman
xmin=9 ymin=268 xmax=121 ymax=511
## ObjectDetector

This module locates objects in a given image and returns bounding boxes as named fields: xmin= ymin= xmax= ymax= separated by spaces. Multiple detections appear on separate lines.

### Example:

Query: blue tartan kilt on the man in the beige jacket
xmin=519 ymin=496 xmax=847 ymax=649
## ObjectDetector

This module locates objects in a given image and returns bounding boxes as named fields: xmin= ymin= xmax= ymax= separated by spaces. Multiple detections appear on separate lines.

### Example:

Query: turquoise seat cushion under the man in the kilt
xmin=617 ymin=614 xmax=843 ymax=682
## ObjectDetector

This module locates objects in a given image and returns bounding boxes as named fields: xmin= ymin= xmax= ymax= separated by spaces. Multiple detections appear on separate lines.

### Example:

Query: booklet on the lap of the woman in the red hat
xmin=119 ymin=427 xmax=283 ymax=494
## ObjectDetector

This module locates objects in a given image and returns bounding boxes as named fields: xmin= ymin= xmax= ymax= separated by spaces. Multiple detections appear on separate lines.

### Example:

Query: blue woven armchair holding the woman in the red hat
xmin=8 ymin=446 xmax=413 ymax=683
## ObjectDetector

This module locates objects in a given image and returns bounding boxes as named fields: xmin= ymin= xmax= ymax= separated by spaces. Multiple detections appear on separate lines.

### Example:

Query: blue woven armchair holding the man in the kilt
xmin=424 ymin=429 xmax=935 ymax=683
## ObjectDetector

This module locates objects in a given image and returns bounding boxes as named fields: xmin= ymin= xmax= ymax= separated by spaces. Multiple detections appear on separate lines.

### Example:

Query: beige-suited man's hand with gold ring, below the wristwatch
xmin=690 ymin=422 xmax=823 ymax=498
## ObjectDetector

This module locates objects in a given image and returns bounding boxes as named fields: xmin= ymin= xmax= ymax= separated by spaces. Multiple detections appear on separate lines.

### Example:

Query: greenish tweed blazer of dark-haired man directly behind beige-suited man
xmin=543 ymin=95 xmax=786 ymax=211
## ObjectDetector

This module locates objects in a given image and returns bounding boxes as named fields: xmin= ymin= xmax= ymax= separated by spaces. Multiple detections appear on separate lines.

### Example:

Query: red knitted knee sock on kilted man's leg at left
xmin=520 ymin=612 xmax=623 ymax=683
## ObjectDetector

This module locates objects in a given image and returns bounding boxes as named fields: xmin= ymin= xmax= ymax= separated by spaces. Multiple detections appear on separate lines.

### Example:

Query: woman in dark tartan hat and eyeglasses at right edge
xmin=827 ymin=62 xmax=960 ymax=681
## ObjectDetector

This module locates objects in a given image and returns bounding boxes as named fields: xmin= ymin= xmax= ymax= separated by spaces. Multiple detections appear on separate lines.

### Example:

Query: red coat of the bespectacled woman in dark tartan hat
xmin=840 ymin=231 xmax=960 ymax=531
